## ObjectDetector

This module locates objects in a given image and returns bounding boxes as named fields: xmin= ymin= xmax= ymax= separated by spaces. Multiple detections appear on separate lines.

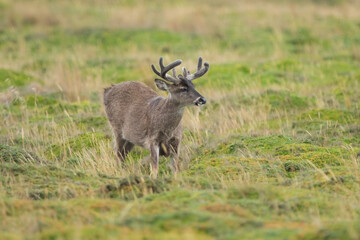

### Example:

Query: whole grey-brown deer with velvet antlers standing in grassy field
xmin=103 ymin=57 xmax=210 ymax=178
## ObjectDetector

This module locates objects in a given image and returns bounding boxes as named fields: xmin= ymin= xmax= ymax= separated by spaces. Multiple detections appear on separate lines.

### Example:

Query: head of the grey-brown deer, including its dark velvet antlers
xmin=151 ymin=57 xmax=210 ymax=106
